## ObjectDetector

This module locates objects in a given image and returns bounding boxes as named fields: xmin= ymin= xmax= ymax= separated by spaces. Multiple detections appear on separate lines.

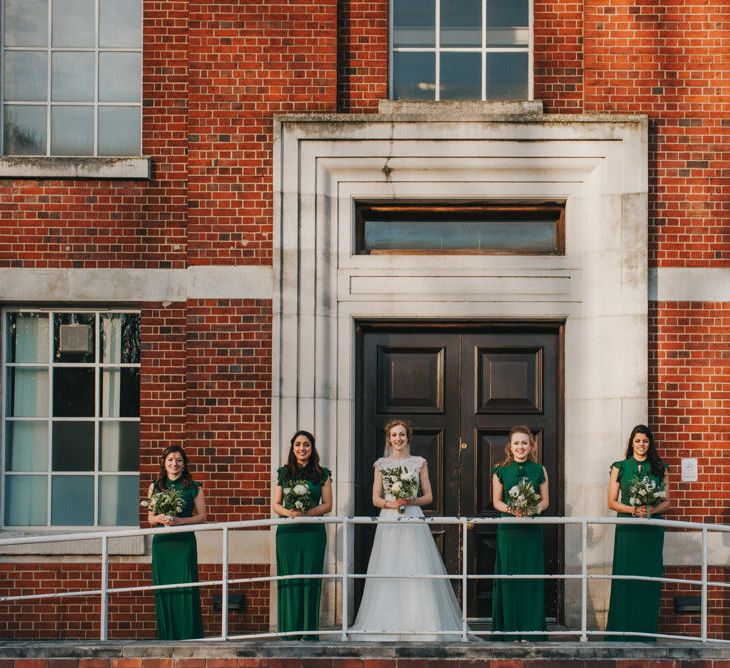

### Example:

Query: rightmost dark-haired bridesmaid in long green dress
xmin=606 ymin=424 xmax=670 ymax=642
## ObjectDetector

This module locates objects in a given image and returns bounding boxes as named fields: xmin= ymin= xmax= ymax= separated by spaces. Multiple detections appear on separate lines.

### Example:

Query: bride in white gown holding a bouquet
xmin=350 ymin=420 xmax=462 ymax=641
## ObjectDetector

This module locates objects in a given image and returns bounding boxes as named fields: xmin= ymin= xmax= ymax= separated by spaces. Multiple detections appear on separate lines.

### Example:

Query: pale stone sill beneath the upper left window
xmin=0 ymin=156 xmax=152 ymax=179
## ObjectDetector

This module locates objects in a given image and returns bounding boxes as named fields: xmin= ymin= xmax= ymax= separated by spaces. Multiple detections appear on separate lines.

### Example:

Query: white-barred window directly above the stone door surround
xmin=391 ymin=0 xmax=532 ymax=100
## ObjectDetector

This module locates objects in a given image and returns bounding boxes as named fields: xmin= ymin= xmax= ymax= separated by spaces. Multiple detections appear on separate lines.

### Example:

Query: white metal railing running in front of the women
xmin=0 ymin=517 xmax=730 ymax=643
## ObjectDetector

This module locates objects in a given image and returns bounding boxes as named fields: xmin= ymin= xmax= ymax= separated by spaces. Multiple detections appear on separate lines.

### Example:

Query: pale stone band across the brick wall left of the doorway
xmin=0 ymin=265 xmax=274 ymax=304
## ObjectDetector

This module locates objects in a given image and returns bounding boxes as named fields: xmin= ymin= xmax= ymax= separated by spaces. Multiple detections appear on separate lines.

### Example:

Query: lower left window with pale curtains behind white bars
xmin=2 ymin=309 xmax=140 ymax=527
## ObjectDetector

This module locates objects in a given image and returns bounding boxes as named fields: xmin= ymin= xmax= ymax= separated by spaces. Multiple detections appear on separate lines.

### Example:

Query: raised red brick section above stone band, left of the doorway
xmin=188 ymin=0 xmax=337 ymax=265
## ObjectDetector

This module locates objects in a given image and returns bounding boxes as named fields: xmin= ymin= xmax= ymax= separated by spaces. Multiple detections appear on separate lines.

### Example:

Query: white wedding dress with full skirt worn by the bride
xmin=350 ymin=456 xmax=462 ymax=642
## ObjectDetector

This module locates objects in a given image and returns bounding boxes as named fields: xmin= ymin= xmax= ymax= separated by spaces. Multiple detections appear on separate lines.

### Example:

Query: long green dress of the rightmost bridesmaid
xmin=606 ymin=457 xmax=666 ymax=642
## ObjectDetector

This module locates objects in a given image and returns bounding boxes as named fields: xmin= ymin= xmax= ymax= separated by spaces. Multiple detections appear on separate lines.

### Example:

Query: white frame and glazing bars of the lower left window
xmin=0 ymin=307 xmax=141 ymax=532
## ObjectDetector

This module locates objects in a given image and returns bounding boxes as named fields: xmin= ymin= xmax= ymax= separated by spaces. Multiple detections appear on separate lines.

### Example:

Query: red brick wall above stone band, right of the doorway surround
xmin=584 ymin=0 xmax=730 ymax=267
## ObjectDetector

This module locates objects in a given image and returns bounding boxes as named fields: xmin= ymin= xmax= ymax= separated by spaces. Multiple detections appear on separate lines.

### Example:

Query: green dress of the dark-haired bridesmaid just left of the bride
xmin=276 ymin=466 xmax=332 ymax=640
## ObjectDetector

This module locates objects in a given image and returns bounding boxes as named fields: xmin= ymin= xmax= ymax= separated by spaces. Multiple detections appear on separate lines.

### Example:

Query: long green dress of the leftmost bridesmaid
xmin=152 ymin=479 xmax=203 ymax=640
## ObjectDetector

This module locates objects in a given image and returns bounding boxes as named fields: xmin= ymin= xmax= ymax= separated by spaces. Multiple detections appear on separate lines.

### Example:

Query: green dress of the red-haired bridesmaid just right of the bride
xmin=491 ymin=462 xmax=547 ymax=640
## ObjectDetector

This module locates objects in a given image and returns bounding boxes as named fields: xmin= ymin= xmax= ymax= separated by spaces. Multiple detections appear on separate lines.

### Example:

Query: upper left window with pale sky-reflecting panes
xmin=0 ymin=0 xmax=142 ymax=157
